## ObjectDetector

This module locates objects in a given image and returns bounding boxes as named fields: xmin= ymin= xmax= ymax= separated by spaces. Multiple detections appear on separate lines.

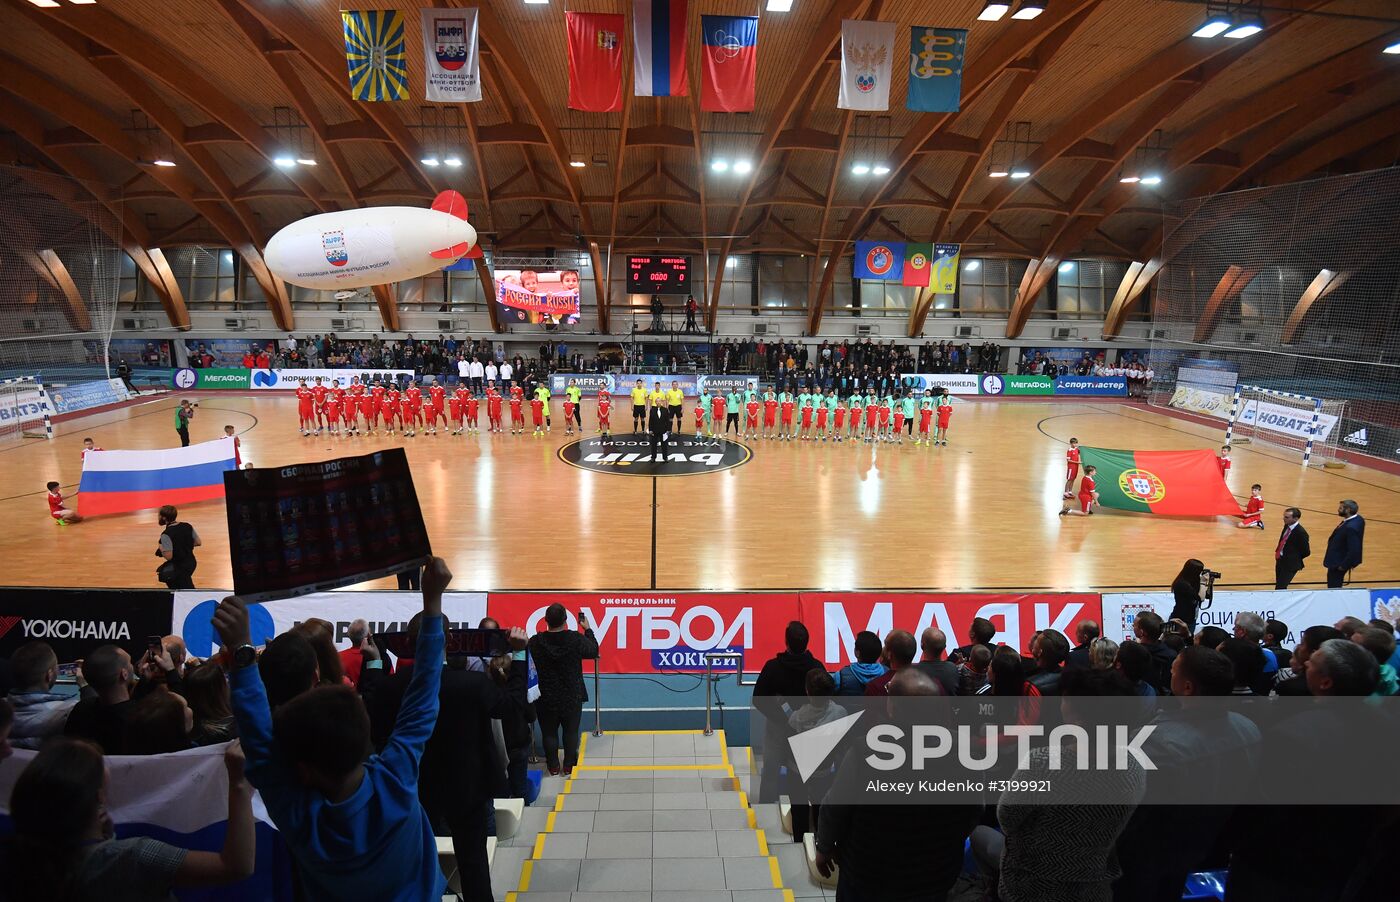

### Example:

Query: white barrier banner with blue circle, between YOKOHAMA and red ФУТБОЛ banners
xmin=171 ymin=590 xmax=486 ymax=658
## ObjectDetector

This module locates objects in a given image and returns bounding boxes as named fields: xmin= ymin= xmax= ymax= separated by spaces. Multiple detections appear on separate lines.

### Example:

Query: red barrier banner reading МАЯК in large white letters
xmin=806 ymin=592 xmax=1097 ymax=668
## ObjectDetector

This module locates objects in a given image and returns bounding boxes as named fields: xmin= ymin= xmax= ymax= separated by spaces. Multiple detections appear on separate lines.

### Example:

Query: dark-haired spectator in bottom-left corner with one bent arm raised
xmin=4 ymin=738 xmax=256 ymax=899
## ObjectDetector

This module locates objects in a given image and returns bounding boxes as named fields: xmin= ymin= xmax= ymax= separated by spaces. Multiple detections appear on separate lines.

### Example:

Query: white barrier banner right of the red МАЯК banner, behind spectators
xmin=1103 ymin=588 xmax=1371 ymax=646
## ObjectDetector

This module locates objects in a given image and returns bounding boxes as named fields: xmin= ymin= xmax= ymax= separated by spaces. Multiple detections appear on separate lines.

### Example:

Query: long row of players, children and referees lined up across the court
xmin=288 ymin=378 xmax=953 ymax=445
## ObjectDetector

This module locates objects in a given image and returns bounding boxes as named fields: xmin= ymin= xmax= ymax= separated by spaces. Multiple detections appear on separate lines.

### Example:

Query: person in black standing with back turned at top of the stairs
xmin=529 ymin=602 xmax=598 ymax=776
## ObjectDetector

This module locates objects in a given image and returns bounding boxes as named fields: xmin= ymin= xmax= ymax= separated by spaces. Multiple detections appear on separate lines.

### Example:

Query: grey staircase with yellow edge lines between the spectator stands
xmin=491 ymin=730 xmax=812 ymax=902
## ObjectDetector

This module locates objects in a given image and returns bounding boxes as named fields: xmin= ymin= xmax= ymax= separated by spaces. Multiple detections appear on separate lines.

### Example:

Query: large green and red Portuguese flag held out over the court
xmin=1079 ymin=448 xmax=1243 ymax=517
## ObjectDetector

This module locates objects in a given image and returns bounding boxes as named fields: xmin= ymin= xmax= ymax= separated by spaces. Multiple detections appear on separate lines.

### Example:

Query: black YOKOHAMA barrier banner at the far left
xmin=0 ymin=588 xmax=171 ymax=664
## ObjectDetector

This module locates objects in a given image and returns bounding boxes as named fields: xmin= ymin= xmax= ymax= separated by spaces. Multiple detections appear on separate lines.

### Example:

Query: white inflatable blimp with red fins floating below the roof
xmin=263 ymin=190 xmax=482 ymax=290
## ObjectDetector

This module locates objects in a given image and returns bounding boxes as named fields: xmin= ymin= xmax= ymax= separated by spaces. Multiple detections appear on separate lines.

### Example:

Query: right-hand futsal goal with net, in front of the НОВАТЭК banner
xmin=1225 ymin=385 xmax=1347 ymax=466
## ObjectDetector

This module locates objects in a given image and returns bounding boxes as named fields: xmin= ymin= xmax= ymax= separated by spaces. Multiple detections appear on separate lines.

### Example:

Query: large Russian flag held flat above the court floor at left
xmin=78 ymin=438 xmax=237 ymax=517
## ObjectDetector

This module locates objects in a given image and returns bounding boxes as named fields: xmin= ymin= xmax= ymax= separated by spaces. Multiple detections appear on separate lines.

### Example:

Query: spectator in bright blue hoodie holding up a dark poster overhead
xmin=214 ymin=557 xmax=452 ymax=902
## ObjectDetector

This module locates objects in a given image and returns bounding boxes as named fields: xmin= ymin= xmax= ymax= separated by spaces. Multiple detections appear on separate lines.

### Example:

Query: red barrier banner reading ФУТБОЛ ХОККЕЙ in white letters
xmin=486 ymin=592 xmax=798 ymax=674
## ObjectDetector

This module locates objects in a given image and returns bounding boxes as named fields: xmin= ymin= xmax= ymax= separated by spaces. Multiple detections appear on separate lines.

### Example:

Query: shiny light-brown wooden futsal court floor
xmin=0 ymin=394 xmax=1400 ymax=591
